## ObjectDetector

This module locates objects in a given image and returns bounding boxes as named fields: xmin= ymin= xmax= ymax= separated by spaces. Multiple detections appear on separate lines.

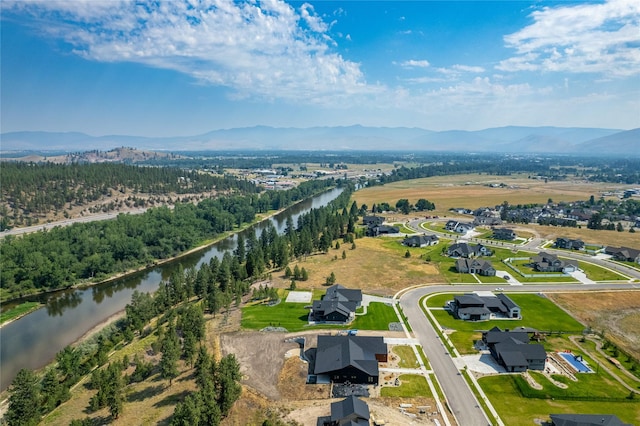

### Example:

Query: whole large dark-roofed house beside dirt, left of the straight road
xmin=313 ymin=335 xmax=388 ymax=384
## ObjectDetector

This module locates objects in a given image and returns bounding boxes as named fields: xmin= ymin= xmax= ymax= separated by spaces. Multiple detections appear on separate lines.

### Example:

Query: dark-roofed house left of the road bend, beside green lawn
xmin=309 ymin=284 xmax=362 ymax=323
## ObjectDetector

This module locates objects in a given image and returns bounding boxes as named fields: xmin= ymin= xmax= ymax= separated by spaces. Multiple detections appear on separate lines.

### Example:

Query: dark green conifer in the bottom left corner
xmin=5 ymin=368 xmax=40 ymax=426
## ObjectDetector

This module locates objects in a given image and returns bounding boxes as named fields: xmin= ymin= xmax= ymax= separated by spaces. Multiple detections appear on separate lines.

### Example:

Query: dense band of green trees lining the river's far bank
xmin=0 ymin=180 xmax=336 ymax=301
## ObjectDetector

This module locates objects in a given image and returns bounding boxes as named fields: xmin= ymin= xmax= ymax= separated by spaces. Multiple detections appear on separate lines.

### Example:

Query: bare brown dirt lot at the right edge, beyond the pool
xmin=547 ymin=291 xmax=640 ymax=359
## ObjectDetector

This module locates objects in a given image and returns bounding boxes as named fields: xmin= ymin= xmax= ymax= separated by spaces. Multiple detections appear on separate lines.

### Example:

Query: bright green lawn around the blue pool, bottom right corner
xmin=478 ymin=374 xmax=640 ymax=425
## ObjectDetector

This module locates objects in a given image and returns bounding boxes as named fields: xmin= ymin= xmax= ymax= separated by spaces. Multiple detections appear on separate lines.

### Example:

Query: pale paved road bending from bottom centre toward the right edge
xmin=400 ymin=284 xmax=639 ymax=426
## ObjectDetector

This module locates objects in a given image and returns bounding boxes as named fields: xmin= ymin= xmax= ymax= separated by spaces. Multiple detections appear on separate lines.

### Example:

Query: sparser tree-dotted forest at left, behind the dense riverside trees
xmin=0 ymin=162 xmax=260 ymax=231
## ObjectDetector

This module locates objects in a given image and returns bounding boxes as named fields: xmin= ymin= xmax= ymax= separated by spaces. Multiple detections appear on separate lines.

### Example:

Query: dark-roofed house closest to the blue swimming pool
xmin=482 ymin=327 xmax=547 ymax=373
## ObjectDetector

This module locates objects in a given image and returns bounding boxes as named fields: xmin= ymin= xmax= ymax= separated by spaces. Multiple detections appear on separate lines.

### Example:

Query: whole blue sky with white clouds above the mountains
xmin=0 ymin=0 xmax=640 ymax=136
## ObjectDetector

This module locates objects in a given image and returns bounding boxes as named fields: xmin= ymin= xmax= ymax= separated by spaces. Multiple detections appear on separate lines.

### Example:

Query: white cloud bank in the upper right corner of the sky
xmin=497 ymin=0 xmax=640 ymax=76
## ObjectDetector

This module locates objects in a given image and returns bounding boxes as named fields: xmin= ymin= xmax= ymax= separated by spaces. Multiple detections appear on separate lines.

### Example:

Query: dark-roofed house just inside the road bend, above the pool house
xmin=449 ymin=293 xmax=521 ymax=321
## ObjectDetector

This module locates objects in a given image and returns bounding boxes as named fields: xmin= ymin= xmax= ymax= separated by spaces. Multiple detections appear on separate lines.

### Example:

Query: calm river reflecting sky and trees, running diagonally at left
xmin=0 ymin=189 xmax=342 ymax=390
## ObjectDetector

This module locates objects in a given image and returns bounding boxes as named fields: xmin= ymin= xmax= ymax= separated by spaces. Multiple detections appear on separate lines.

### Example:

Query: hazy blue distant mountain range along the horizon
xmin=0 ymin=125 xmax=640 ymax=157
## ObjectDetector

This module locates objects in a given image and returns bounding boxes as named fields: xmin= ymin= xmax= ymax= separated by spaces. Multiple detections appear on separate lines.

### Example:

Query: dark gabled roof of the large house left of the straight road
xmin=314 ymin=335 xmax=387 ymax=376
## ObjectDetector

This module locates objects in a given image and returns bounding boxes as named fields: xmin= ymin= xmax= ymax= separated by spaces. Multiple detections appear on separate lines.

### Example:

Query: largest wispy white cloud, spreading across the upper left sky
xmin=3 ymin=0 xmax=380 ymax=102
